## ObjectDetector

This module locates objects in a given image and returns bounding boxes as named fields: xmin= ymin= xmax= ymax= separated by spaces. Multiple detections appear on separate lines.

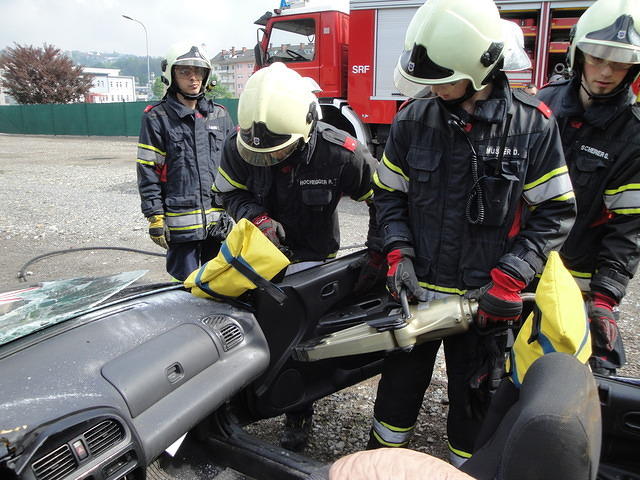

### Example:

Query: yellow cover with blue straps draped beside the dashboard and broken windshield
xmin=184 ymin=218 xmax=290 ymax=300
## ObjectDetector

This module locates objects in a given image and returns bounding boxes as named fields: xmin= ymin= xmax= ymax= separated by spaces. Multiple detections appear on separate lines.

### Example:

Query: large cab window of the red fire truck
xmin=268 ymin=18 xmax=316 ymax=63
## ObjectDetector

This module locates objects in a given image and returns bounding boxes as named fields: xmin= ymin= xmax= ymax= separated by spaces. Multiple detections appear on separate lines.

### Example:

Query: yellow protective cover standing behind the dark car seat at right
xmin=507 ymin=251 xmax=591 ymax=387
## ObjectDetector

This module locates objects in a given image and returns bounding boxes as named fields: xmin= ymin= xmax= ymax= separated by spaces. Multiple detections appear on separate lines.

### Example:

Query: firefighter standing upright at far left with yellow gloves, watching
xmin=137 ymin=44 xmax=233 ymax=281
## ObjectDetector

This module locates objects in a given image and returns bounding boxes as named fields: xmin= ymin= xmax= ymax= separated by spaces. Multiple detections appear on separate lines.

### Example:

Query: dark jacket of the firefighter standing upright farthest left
xmin=137 ymin=94 xmax=234 ymax=243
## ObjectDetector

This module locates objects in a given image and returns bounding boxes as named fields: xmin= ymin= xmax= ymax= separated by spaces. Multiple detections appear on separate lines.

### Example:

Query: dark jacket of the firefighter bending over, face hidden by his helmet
xmin=215 ymin=122 xmax=377 ymax=261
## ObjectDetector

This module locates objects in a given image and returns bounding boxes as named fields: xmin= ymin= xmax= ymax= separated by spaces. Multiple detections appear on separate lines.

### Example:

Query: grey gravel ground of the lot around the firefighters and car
xmin=0 ymin=134 xmax=640 ymax=468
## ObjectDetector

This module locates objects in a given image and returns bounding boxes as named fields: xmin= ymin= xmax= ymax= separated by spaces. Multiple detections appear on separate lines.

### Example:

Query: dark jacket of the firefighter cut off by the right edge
xmin=538 ymin=80 xmax=640 ymax=301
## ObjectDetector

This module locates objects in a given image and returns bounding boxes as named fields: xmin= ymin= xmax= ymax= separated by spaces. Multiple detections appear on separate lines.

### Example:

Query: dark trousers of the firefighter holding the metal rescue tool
xmin=369 ymin=331 xmax=490 ymax=458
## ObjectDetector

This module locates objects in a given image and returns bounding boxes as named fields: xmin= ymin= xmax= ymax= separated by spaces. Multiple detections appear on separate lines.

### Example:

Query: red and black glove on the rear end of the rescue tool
xmin=477 ymin=268 xmax=526 ymax=328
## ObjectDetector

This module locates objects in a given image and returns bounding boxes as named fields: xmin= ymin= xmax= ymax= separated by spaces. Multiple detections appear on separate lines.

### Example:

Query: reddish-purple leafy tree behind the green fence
xmin=0 ymin=43 xmax=93 ymax=104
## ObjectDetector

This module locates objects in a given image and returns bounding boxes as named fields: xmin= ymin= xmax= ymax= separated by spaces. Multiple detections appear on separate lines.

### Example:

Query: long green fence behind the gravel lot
xmin=0 ymin=98 xmax=238 ymax=137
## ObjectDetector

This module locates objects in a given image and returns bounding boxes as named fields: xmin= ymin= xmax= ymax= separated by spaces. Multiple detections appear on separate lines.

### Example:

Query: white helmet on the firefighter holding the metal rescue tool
xmin=394 ymin=0 xmax=504 ymax=98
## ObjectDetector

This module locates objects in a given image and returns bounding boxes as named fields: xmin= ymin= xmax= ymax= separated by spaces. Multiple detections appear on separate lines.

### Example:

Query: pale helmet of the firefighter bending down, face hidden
xmin=236 ymin=62 xmax=320 ymax=167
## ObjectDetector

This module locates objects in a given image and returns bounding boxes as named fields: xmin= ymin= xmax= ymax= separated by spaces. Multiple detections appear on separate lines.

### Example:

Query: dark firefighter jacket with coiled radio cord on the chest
xmin=374 ymin=75 xmax=576 ymax=294
